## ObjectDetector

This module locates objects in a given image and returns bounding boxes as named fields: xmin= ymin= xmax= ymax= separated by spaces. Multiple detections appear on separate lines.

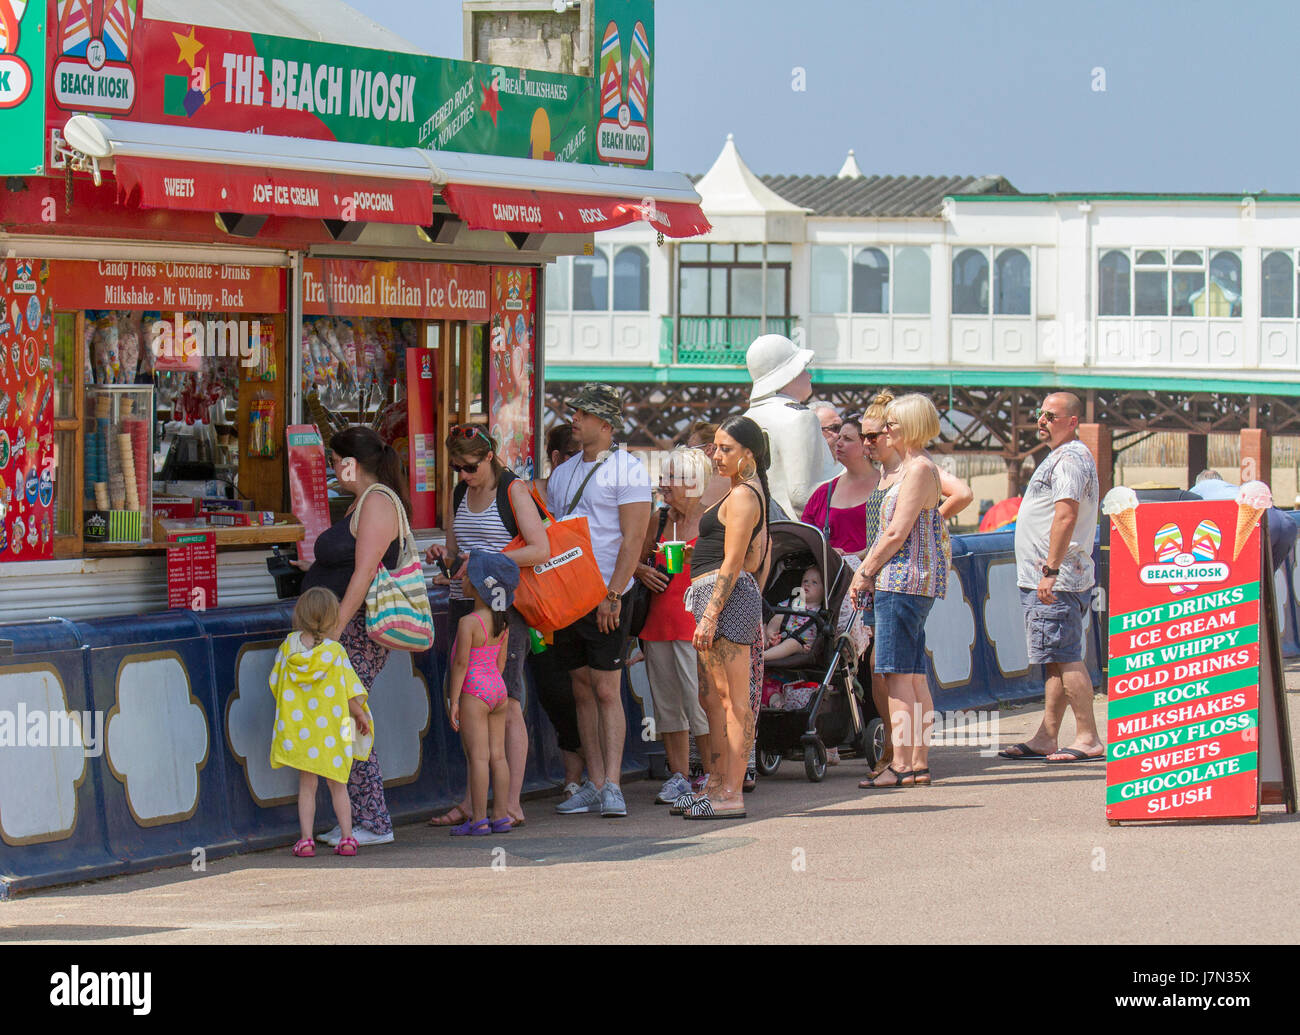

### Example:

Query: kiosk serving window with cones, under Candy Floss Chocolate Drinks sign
xmin=46 ymin=260 xmax=289 ymax=555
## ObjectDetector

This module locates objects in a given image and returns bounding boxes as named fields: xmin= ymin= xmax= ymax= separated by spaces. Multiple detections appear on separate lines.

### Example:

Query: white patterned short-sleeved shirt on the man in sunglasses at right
xmin=1015 ymin=438 xmax=1099 ymax=593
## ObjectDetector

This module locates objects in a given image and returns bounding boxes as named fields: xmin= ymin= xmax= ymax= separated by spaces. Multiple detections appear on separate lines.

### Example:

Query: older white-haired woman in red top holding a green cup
xmin=636 ymin=447 xmax=714 ymax=805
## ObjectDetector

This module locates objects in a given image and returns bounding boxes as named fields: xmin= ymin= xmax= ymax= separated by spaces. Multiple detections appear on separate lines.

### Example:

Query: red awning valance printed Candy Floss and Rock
xmin=442 ymin=183 xmax=710 ymax=237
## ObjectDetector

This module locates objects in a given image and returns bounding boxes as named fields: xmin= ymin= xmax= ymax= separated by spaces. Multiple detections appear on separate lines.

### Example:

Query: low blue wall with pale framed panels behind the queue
xmin=0 ymin=517 xmax=1300 ymax=897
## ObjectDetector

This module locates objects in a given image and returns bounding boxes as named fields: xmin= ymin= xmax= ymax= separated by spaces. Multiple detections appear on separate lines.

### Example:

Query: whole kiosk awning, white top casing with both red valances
xmin=64 ymin=116 xmax=711 ymax=238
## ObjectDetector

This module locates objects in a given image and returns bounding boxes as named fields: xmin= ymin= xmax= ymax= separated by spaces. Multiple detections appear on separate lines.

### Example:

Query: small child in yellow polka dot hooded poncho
xmin=270 ymin=586 xmax=374 ymax=857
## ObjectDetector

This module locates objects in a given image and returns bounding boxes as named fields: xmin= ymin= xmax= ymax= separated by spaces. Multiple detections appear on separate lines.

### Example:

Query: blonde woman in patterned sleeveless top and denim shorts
xmin=849 ymin=394 xmax=952 ymax=788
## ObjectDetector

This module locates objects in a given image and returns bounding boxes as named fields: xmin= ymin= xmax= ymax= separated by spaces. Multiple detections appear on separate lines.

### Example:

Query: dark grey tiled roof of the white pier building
xmin=743 ymin=176 xmax=1019 ymax=218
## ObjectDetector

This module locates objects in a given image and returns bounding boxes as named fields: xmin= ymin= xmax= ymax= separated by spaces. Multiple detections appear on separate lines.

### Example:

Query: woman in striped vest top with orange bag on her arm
xmin=425 ymin=424 xmax=550 ymax=827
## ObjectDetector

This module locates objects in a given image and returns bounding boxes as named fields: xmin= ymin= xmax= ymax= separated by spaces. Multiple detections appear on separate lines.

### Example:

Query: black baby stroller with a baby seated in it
xmin=757 ymin=521 xmax=884 ymax=783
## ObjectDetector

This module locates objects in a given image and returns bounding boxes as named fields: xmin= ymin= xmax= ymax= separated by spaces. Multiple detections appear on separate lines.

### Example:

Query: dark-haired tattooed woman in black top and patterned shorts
xmin=673 ymin=416 xmax=770 ymax=819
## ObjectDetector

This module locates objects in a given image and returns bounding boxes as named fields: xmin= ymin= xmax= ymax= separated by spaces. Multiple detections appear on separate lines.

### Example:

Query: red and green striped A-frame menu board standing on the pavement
xmin=1106 ymin=489 xmax=1273 ymax=820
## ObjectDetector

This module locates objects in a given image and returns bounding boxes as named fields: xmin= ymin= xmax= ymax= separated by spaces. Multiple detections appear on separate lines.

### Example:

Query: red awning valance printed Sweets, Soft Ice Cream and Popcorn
xmin=113 ymin=157 xmax=433 ymax=226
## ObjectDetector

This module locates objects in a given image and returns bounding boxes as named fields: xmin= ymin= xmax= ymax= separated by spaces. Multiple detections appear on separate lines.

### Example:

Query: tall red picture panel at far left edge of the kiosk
xmin=0 ymin=259 xmax=55 ymax=562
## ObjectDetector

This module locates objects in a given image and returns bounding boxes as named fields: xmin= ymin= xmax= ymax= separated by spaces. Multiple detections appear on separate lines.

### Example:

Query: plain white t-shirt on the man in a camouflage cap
xmin=546 ymin=449 xmax=650 ymax=593
